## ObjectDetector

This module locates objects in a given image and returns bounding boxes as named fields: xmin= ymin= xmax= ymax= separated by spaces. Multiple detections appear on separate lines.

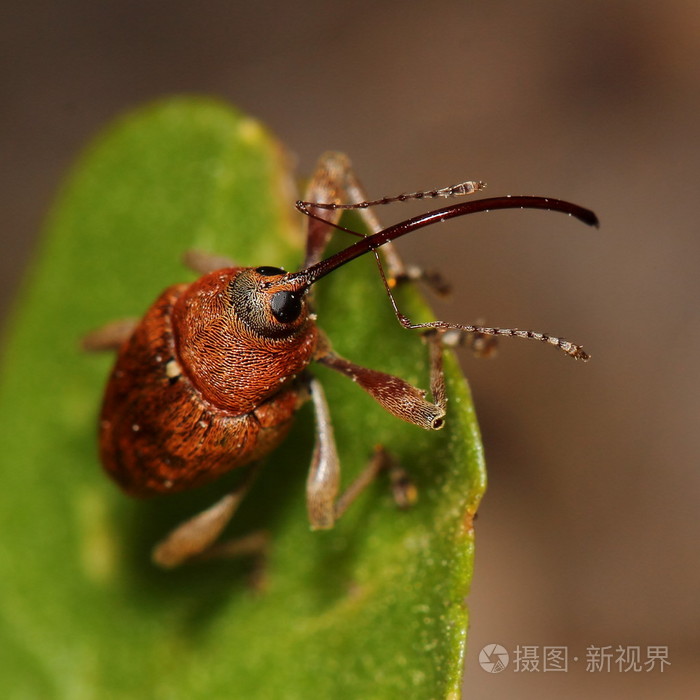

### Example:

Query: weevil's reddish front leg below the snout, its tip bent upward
xmin=316 ymin=331 xmax=447 ymax=430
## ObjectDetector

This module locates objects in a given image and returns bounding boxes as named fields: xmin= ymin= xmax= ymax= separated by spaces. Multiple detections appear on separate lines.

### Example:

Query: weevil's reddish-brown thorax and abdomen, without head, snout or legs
xmin=100 ymin=268 xmax=318 ymax=496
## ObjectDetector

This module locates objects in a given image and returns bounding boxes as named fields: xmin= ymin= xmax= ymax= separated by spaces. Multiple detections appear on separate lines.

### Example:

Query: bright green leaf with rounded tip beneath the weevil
xmin=0 ymin=99 xmax=485 ymax=700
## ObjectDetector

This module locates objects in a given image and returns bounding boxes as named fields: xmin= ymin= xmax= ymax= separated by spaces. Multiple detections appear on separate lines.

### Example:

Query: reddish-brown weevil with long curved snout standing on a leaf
xmin=85 ymin=153 xmax=597 ymax=568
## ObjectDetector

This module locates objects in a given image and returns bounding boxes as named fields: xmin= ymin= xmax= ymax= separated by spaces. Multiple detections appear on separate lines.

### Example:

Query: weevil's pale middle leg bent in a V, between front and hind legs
xmin=306 ymin=378 xmax=417 ymax=530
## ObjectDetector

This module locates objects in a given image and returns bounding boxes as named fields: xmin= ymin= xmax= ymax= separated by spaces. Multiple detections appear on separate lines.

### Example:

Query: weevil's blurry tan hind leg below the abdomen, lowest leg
xmin=151 ymin=463 xmax=260 ymax=569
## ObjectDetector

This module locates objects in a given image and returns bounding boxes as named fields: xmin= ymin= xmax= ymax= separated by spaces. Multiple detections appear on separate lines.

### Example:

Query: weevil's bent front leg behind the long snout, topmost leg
xmin=304 ymin=151 xmax=450 ymax=295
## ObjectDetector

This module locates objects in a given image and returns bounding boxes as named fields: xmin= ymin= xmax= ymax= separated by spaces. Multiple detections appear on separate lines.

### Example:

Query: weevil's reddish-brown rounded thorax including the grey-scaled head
xmin=173 ymin=268 xmax=317 ymax=415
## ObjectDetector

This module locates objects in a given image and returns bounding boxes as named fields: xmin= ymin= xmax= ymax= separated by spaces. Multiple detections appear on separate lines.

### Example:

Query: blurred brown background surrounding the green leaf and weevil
xmin=0 ymin=0 xmax=700 ymax=698
